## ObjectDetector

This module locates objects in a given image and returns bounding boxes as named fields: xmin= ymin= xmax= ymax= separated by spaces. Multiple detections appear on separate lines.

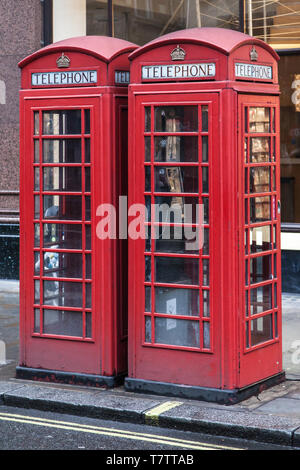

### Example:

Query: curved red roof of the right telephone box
xmin=129 ymin=28 xmax=279 ymax=60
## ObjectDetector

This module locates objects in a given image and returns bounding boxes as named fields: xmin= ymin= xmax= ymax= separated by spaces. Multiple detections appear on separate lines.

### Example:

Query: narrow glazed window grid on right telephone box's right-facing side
xmin=243 ymin=106 xmax=278 ymax=351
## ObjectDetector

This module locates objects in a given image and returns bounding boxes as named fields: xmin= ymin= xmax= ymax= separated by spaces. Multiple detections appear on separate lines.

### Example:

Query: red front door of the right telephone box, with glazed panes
xmin=129 ymin=90 xmax=222 ymax=387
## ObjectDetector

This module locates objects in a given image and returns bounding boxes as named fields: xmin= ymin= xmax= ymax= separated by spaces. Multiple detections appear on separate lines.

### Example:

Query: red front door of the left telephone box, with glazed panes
xmin=21 ymin=96 xmax=102 ymax=374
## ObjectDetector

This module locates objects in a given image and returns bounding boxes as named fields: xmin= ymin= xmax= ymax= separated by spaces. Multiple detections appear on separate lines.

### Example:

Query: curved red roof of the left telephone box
xmin=18 ymin=36 xmax=138 ymax=68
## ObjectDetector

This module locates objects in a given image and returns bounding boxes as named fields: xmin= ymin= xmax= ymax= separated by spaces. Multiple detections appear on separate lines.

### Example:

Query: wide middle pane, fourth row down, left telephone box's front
xmin=43 ymin=195 xmax=82 ymax=220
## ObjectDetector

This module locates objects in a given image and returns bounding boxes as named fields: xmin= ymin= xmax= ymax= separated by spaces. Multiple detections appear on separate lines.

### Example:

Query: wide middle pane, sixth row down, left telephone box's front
xmin=44 ymin=252 xmax=82 ymax=279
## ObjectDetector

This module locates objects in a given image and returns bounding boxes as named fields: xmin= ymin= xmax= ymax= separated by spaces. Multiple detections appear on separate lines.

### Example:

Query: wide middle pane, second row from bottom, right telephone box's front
xmin=155 ymin=287 xmax=199 ymax=316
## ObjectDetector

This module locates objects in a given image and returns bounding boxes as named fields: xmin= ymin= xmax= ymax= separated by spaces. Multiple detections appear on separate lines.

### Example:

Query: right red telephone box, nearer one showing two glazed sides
xmin=125 ymin=28 xmax=284 ymax=403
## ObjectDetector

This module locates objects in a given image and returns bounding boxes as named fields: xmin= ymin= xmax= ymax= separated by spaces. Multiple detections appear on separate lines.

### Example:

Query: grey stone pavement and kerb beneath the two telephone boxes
xmin=0 ymin=281 xmax=300 ymax=449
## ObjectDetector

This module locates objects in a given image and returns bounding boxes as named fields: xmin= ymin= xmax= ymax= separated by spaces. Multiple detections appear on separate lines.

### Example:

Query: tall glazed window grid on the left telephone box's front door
xmin=33 ymin=109 xmax=92 ymax=341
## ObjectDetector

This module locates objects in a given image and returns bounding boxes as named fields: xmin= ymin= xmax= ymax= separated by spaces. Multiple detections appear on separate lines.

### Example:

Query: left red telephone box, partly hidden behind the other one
xmin=17 ymin=36 xmax=136 ymax=386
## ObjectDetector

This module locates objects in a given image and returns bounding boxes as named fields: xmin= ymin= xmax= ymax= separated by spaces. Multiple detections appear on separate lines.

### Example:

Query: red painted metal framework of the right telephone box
xmin=126 ymin=28 xmax=282 ymax=391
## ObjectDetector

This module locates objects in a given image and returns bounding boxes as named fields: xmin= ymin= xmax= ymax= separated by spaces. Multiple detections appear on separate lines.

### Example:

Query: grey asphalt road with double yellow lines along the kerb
xmin=0 ymin=406 xmax=291 ymax=454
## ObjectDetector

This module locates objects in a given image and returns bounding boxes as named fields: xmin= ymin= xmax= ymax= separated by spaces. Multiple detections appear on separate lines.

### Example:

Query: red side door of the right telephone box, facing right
xmin=238 ymin=95 xmax=282 ymax=387
